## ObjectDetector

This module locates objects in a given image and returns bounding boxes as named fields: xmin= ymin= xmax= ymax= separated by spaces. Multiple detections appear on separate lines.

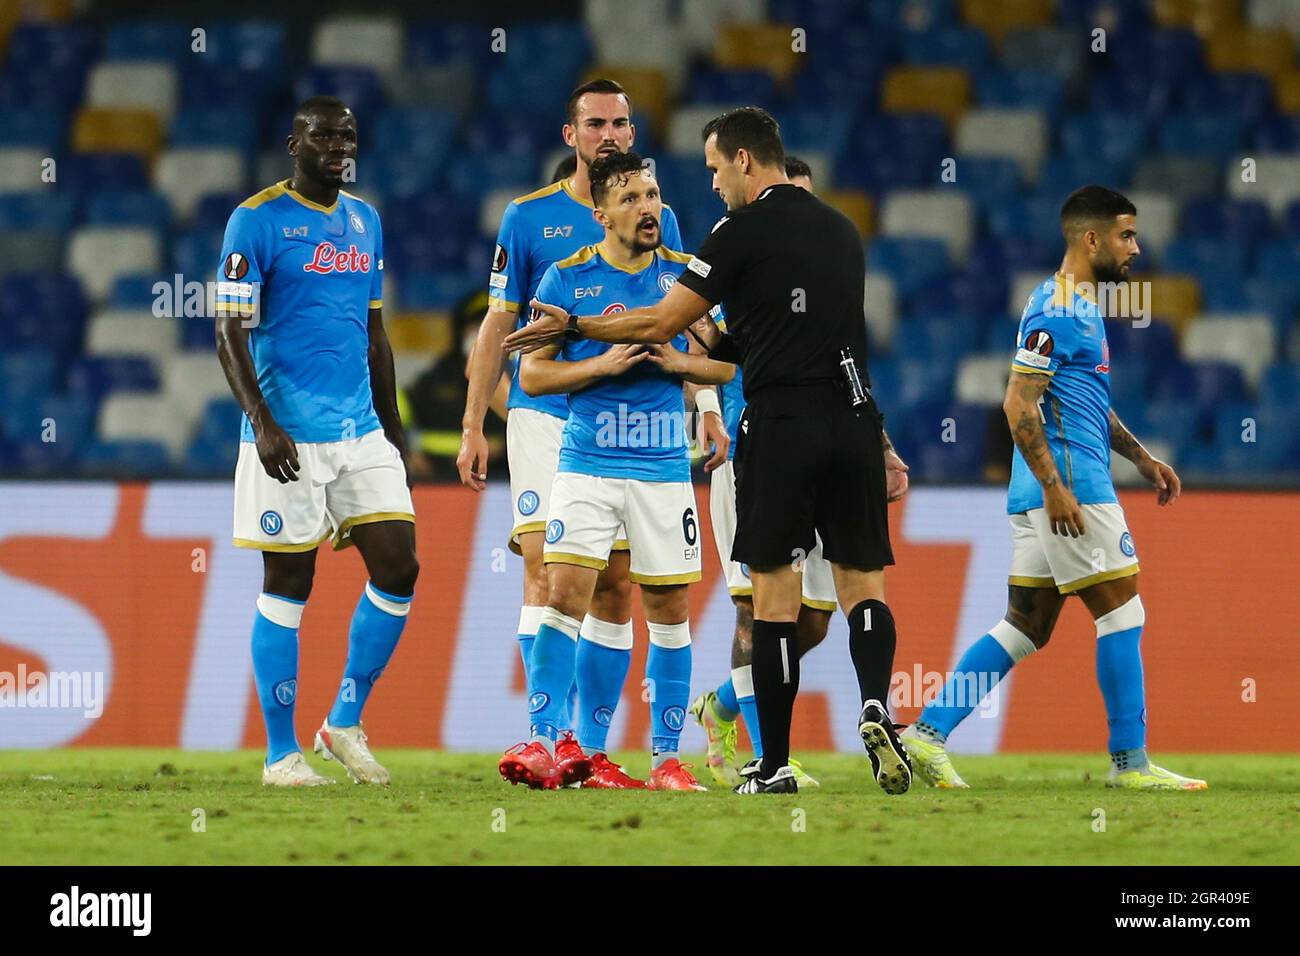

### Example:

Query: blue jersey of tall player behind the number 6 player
xmin=488 ymin=179 xmax=681 ymax=419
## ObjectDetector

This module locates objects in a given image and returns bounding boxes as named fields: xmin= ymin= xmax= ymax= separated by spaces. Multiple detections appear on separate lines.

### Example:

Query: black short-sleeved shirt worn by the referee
xmin=679 ymin=185 xmax=870 ymax=403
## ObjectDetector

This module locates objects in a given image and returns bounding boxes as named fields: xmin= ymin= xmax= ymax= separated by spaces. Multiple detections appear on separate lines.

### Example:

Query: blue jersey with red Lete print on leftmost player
xmin=216 ymin=179 xmax=384 ymax=442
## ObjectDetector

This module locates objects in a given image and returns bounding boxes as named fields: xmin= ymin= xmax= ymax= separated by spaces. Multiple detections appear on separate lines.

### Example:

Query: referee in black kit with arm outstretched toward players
xmin=506 ymin=107 xmax=911 ymax=793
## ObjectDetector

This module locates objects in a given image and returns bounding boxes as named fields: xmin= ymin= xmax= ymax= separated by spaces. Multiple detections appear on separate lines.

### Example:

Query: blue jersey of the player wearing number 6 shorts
xmin=538 ymin=246 xmax=690 ymax=481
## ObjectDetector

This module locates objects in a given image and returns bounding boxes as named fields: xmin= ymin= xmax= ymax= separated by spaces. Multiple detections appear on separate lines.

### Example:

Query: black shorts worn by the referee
xmin=732 ymin=389 xmax=894 ymax=571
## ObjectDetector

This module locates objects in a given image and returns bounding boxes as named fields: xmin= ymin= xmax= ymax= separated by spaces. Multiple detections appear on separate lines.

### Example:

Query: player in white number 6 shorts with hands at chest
xmin=501 ymin=152 xmax=736 ymax=790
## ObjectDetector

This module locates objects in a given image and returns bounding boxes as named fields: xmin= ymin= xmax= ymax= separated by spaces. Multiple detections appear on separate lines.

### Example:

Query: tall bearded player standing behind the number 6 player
xmin=456 ymin=79 xmax=725 ymax=778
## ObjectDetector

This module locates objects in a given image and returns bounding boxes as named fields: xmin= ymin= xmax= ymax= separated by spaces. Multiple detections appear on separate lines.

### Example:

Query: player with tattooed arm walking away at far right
xmin=902 ymin=186 xmax=1206 ymax=790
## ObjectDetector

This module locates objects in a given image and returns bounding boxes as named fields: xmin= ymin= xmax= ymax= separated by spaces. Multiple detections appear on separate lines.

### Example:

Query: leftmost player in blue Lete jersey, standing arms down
xmin=217 ymin=96 xmax=419 ymax=787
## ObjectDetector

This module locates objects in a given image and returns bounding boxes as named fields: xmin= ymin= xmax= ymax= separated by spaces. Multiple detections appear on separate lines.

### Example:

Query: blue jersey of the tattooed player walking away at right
xmin=1006 ymin=273 xmax=1118 ymax=514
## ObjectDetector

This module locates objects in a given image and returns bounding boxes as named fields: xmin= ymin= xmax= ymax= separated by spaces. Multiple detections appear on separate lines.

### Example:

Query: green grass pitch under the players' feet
xmin=0 ymin=749 xmax=1300 ymax=865
